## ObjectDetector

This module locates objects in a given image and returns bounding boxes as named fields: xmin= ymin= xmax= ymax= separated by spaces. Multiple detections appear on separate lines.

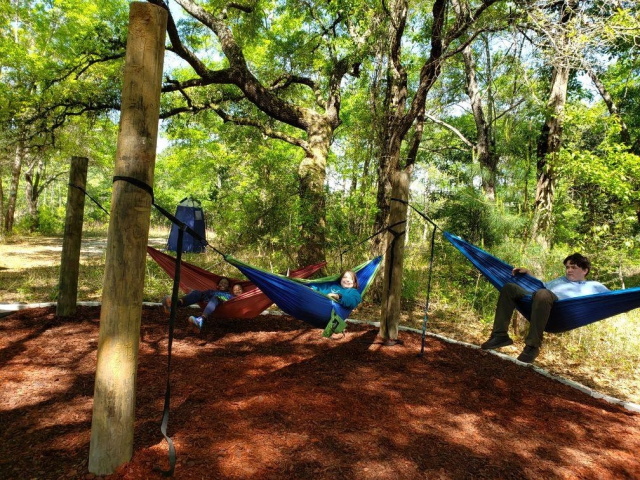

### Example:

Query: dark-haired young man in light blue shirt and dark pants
xmin=481 ymin=253 xmax=609 ymax=363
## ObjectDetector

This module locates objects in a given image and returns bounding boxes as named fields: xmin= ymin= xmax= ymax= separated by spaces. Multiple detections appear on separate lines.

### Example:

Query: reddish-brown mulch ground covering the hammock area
xmin=0 ymin=307 xmax=640 ymax=479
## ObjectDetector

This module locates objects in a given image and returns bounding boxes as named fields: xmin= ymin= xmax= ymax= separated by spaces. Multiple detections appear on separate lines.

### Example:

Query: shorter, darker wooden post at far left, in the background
xmin=56 ymin=157 xmax=89 ymax=317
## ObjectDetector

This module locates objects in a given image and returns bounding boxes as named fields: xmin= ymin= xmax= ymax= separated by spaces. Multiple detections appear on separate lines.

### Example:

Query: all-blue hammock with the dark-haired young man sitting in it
xmin=444 ymin=232 xmax=640 ymax=333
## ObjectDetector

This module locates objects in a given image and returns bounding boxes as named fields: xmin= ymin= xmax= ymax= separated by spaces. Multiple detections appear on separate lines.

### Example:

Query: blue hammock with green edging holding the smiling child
xmin=225 ymin=256 xmax=382 ymax=336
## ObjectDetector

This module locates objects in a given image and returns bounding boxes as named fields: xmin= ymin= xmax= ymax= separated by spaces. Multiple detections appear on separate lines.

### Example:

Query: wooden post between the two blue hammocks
xmin=380 ymin=172 xmax=409 ymax=344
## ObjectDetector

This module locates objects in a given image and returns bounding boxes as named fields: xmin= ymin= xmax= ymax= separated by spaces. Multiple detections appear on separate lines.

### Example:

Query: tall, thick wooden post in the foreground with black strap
xmin=89 ymin=2 xmax=167 ymax=475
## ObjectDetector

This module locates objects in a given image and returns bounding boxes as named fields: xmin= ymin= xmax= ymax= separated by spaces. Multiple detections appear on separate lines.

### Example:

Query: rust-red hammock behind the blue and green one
xmin=147 ymin=247 xmax=327 ymax=318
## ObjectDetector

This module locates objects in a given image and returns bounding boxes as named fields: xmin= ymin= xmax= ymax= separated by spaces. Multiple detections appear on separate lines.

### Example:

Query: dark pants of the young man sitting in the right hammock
xmin=491 ymin=283 xmax=558 ymax=347
